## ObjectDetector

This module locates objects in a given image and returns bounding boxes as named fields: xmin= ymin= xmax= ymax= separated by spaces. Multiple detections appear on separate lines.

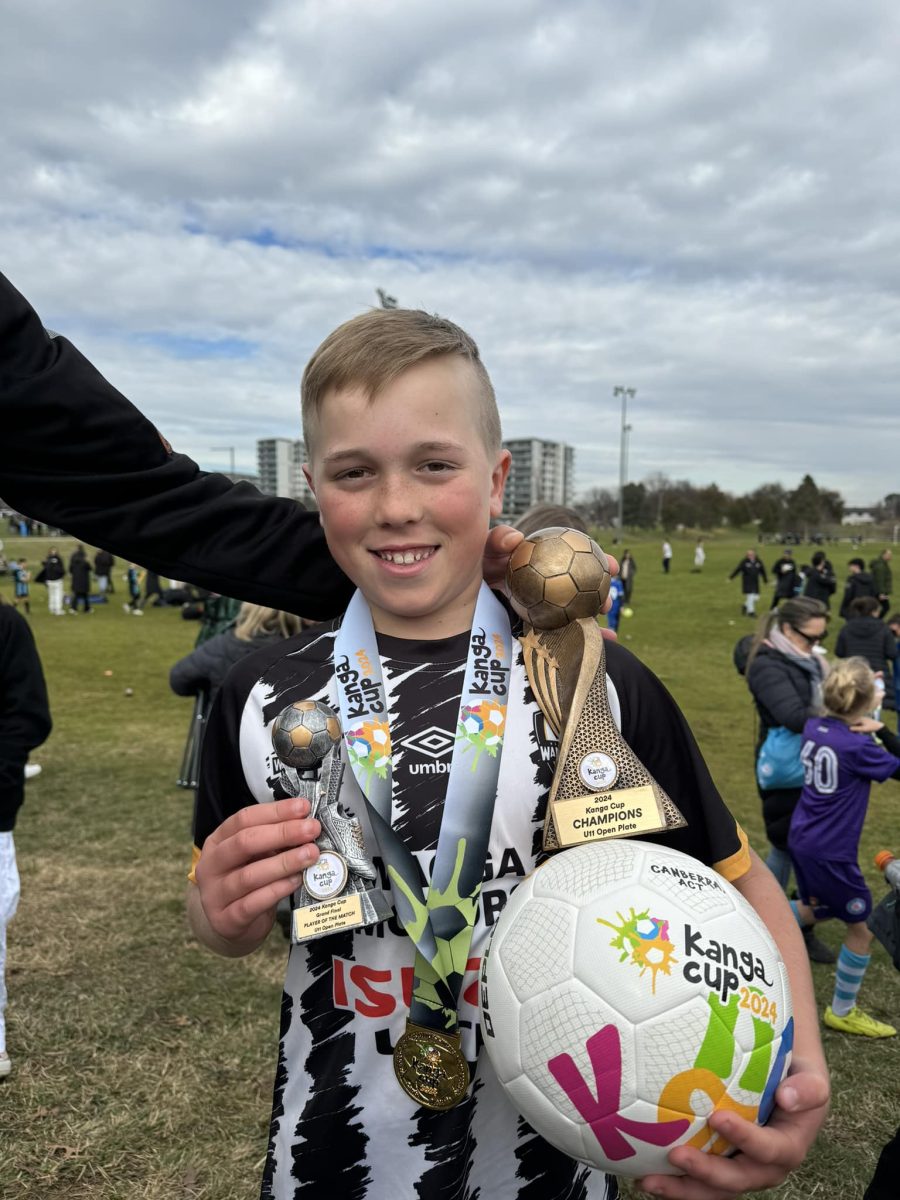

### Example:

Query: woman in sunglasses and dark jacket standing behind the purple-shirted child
xmin=746 ymin=596 xmax=835 ymax=962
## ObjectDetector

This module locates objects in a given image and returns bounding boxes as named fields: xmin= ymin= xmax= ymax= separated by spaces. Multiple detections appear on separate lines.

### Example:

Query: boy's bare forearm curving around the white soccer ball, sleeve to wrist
xmin=734 ymin=851 xmax=828 ymax=1075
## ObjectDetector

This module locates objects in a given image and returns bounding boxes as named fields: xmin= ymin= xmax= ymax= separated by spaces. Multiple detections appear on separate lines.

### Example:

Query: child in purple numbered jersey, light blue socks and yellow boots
xmin=787 ymin=658 xmax=900 ymax=1038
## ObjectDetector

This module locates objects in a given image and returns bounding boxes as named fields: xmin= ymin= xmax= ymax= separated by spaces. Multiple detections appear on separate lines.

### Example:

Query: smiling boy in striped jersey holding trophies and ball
xmin=187 ymin=310 xmax=827 ymax=1200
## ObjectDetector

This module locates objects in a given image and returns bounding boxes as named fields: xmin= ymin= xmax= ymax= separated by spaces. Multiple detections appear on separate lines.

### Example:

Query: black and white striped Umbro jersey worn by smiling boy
xmin=194 ymin=626 xmax=749 ymax=1200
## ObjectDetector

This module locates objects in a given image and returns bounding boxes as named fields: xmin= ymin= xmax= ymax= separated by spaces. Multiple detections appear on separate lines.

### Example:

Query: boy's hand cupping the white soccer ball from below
xmin=637 ymin=1058 xmax=829 ymax=1200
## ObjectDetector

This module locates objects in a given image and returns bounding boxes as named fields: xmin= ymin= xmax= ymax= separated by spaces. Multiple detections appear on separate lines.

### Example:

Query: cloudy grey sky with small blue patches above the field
xmin=0 ymin=0 xmax=900 ymax=504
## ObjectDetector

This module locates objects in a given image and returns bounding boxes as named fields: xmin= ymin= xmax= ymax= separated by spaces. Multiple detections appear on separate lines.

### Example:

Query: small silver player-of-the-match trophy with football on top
xmin=272 ymin=700 xmax=391 ymax=942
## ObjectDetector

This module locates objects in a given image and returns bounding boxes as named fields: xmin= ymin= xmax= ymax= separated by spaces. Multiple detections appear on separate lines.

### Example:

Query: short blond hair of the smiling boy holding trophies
xmin=300 ymin=308 xmax=502 ymax=455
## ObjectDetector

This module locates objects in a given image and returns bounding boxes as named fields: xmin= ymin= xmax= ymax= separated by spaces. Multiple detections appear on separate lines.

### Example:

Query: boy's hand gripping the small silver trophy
xmin=194 ymin=799 xmax=322 ymax=953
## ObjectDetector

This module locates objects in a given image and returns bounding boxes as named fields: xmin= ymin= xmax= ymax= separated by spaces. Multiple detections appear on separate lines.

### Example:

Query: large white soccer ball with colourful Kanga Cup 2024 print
xmin=480 ymin=840 xmax=793 ymax=1176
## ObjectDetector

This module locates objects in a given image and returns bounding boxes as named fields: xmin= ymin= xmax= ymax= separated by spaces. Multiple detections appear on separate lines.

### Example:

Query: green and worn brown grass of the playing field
xmin=0 ymin=538 xmax=900 ymax=1200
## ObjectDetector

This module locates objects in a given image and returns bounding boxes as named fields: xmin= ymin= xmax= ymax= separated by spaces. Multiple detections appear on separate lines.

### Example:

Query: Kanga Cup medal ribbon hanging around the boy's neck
xmin=335 ymin=583 xmax=512 ymax=1032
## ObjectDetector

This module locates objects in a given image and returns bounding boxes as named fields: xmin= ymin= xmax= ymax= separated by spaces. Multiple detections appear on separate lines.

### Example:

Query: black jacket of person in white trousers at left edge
xmin=0 ymin=602 xmax=52 ymax=833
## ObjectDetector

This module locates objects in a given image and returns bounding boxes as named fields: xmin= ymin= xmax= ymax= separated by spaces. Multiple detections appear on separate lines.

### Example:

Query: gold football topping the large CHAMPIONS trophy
xmin=506 ymin=526 xmax=610 ymax=629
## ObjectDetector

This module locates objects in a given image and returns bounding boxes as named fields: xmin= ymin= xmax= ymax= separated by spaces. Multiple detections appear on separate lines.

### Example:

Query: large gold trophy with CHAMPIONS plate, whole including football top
xmin=506 ymin=527 xmax=686 ymax=850
